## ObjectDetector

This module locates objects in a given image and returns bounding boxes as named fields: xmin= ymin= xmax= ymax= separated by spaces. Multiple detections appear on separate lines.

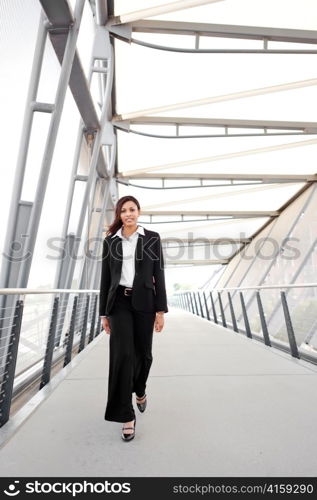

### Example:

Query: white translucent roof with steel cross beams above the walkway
xmin=106 ymin=0 xmax=317 ymax=274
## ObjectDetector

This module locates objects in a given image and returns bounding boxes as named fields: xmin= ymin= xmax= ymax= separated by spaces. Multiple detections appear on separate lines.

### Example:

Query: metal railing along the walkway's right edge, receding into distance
xmin=170 ymin=283 xmax=317 ymax=364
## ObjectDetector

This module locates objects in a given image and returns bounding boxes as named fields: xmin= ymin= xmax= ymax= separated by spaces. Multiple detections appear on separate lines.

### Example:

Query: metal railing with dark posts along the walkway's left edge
xmin=0 ymin=288 xmax=102 ymax=427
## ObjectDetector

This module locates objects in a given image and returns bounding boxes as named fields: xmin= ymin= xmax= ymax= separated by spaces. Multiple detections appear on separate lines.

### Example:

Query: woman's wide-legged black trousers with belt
xmin=105 ymin=286 xmax=155 ymax=422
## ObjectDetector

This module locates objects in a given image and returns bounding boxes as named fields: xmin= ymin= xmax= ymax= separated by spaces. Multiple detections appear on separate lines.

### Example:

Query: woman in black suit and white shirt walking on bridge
xmin=100 ymin=196 xmax=168 ymax=441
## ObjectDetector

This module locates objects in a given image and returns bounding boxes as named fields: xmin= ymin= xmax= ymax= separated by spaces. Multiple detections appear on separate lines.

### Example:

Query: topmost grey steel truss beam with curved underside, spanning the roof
xmin=108 ymin=19 xmax=317 ymax=54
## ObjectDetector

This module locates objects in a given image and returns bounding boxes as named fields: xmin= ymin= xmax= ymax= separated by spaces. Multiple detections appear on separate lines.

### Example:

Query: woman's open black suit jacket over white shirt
xmin=99 ymin=228 xmax=168 ymax=316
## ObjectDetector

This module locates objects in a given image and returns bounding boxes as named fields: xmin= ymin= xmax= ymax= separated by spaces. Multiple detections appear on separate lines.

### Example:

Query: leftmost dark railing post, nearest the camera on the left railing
xmin=0 ymin=300 xmax=23 ymax=427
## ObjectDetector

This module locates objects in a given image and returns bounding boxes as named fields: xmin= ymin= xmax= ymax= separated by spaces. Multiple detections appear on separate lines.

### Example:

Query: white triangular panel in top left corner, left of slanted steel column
xmin=0 ymin=0 xmax=41 ymax=270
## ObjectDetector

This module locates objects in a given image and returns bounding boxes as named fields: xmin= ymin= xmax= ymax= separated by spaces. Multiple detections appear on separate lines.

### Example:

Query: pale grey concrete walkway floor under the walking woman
xmin=0 ymin=308 xmax=317 ymax=477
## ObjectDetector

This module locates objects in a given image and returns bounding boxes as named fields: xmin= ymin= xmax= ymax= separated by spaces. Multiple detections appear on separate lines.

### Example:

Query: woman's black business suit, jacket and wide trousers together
xmin=99 ymin=229 xmax=168 ymax=422
